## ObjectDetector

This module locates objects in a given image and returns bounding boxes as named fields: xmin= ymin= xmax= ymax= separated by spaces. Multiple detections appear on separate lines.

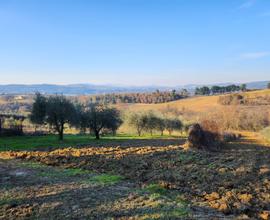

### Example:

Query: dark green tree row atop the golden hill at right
xmin=195 ymin=84 xmax=247 ymax=95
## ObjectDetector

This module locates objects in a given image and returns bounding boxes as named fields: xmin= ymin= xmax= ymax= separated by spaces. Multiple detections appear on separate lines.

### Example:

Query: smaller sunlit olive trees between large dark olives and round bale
xmin=128 ymin=111 xmax=183 ymax=136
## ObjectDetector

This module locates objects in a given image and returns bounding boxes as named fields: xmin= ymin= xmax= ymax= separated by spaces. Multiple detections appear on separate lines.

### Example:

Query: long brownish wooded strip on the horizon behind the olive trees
xmin=83 ymin=89 xmax=189 ymax=104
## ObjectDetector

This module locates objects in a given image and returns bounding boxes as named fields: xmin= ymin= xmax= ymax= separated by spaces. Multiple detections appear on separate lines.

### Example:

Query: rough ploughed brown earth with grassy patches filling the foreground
xmin=0 ymin=133 xmax=270 ymax=219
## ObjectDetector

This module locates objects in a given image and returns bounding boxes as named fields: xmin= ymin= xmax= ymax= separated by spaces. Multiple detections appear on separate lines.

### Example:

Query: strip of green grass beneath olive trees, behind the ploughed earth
xmin=0 ymin=132 xmax=175 ymax=151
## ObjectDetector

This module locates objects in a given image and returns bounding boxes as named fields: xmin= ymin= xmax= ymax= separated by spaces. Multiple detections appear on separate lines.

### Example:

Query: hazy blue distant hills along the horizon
xmin=0 ymin=81 xmax=269 ymax=95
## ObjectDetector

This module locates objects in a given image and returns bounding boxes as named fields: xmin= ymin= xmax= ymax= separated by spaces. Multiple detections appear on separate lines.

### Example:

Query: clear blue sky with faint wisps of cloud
xmin=0 ymin=0 xmax=270 ymax=86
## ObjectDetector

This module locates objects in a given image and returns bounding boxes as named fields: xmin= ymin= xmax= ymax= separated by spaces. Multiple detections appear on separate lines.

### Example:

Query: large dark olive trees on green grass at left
xmin=30 ymin=93 xmax=122 ymax=140
